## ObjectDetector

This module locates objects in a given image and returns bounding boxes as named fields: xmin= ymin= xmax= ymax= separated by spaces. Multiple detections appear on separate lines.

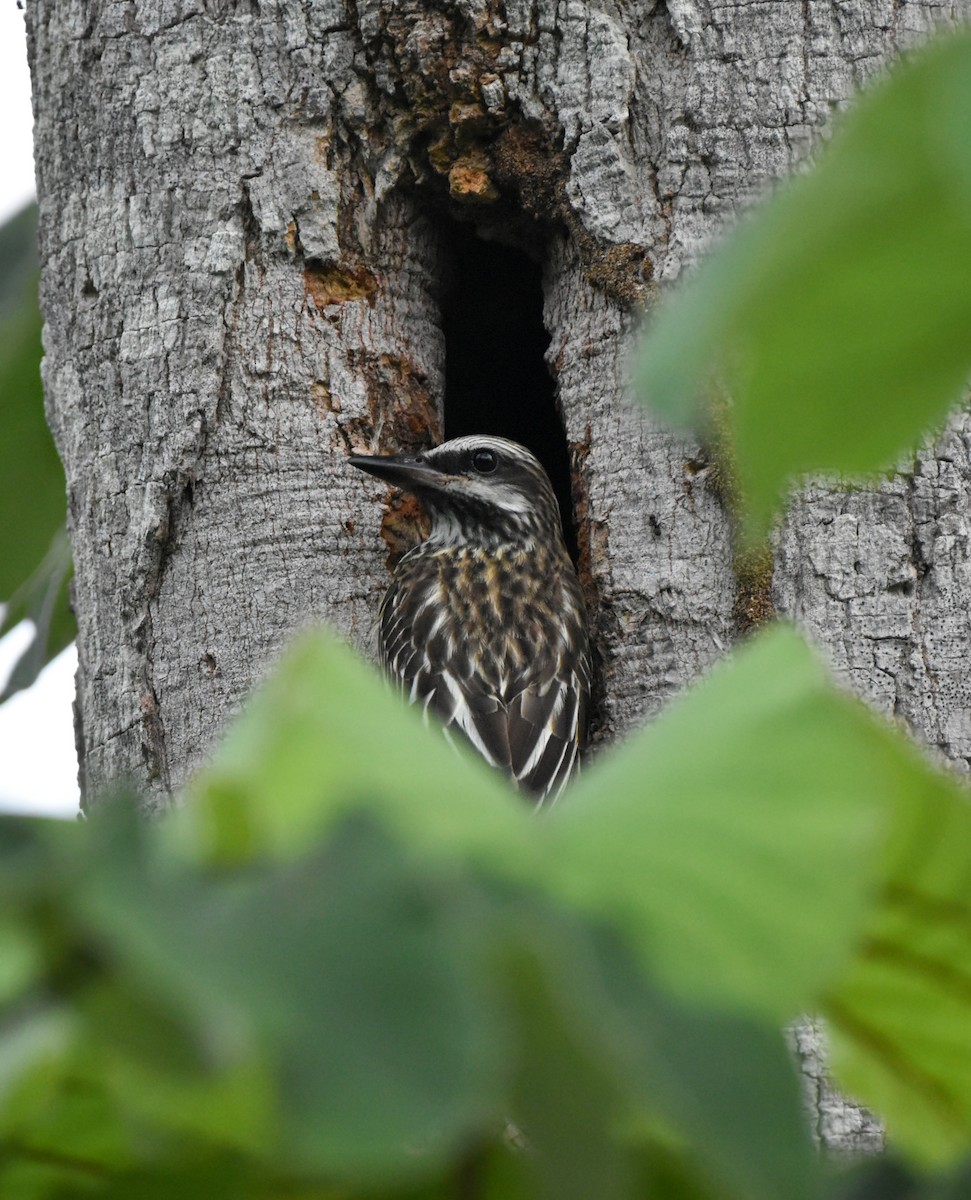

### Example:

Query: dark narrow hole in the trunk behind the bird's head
xmin=440 ymin=218 xmax=577 ymax=562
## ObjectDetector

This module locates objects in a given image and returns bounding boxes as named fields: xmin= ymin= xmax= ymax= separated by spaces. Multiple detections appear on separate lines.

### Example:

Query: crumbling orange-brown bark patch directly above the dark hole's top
xmin=342 ymin=0 xmax=653 ymax=307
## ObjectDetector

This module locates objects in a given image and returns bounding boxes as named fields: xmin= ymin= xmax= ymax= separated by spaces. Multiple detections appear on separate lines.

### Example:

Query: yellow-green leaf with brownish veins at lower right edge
xmin=823 ymin=769 xmax=971 ymax=1165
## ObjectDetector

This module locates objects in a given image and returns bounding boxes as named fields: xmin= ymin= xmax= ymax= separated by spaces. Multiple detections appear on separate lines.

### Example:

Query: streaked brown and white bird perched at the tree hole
xmin=348 ymin=434 xmax=591 ymax=805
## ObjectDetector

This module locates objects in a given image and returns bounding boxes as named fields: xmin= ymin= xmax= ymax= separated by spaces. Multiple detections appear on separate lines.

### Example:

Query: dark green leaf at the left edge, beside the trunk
xmin=0 ymin=205 xmax=74 ymax=702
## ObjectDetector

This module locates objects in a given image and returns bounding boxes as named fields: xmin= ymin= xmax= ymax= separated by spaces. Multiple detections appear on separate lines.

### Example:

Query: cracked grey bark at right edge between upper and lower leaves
xmin=774 ymin=412 xmax=971 ymax=773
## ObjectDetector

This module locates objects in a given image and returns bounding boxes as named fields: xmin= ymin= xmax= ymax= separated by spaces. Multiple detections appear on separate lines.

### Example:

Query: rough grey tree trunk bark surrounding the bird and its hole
xmin=28 ymin=0 xmax=971 ymax=1148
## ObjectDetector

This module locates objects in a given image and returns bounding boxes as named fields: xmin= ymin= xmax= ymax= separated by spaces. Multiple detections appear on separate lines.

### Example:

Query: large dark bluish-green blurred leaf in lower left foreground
xmin=76 ymin=817 xmax=509 ymax=1180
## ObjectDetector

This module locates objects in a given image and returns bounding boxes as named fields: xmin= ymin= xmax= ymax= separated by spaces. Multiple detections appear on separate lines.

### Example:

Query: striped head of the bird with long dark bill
xmin=348 ymin=434 xmax=563 ymax=546
